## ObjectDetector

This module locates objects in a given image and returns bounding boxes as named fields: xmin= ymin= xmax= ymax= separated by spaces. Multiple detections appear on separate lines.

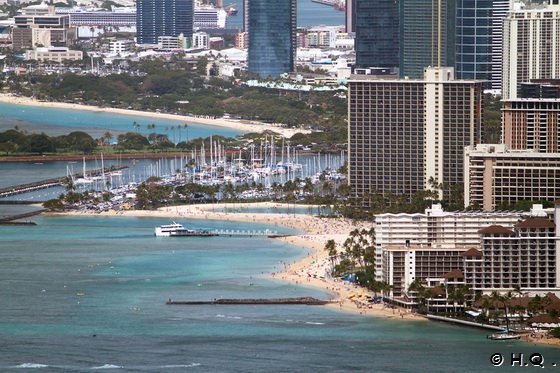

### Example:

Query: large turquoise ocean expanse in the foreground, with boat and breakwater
xmin=0 ymin=216 xmax=560 ymax=372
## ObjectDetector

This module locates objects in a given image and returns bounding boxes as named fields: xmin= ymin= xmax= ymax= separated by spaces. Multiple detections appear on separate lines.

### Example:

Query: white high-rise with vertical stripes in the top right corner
xmin=502 ymin=0 xmax=560 ymax=100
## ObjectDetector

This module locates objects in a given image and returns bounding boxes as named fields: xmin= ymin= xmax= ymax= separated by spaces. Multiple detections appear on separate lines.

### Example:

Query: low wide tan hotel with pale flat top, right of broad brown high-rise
xmin=464 ymin=144 xmax=560 ymax=211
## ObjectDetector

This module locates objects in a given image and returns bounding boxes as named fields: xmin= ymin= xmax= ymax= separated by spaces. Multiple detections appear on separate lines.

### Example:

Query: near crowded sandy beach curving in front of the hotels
xmin=50 ymin=202 xmax=426 ymax=320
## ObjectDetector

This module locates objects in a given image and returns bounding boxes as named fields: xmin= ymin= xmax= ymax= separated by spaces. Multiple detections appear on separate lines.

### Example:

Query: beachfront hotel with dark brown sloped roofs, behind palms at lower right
xmin=376 ymin=205 xmax=560 ymax=307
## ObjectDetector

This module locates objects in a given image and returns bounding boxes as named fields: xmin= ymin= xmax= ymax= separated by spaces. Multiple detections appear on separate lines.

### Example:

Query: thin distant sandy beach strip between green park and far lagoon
xmin=0 ymin=93 xmax=312 ymax=138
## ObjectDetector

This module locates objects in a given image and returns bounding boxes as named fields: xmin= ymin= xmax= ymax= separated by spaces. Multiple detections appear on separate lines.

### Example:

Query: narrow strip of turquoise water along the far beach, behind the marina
xmin=0 ymin=102 xmax=243 ymax=142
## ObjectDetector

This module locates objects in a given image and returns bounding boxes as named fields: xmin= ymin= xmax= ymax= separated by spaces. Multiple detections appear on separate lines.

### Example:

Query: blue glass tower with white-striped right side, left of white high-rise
xmin=455 ymin=0 xmax=510 ymax=89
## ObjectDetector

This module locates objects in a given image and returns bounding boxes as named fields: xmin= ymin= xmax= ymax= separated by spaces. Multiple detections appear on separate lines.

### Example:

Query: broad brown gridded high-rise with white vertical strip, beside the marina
xmin=348 ymin=67 xmax=483 ymax=207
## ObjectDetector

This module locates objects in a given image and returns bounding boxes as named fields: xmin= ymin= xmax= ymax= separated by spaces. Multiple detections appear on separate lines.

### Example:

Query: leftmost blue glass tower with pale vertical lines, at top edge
xmin=136 ymin=0 xmax=194 ymax=44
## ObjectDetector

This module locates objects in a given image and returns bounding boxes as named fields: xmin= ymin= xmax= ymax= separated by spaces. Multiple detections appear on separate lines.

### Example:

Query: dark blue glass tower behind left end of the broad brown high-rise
xmin=354 ymin=0 xmax=399 ymax=67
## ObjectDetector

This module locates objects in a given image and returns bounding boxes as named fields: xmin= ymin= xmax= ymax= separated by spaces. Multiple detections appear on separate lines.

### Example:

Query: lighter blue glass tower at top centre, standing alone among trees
xmin=247 ymin=0 xmax=297 ymax=77
